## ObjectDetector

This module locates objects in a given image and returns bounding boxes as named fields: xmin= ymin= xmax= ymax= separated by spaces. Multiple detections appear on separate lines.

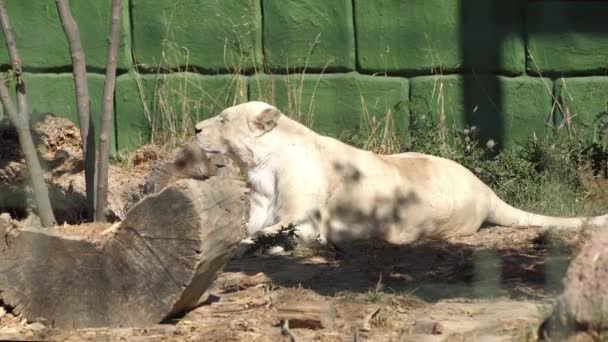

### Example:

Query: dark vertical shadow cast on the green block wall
xmin=459 ymin=0 xmax=525 ymax=148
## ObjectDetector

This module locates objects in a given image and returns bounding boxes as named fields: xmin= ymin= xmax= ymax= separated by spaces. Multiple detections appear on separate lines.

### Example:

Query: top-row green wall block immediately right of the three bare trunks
xmin=131 ymin=0 xmax=262 ymax=73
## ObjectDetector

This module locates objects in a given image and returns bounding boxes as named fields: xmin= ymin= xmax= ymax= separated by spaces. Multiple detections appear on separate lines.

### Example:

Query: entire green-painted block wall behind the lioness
xmin=0 ymin=0 xmax=608 ymax=150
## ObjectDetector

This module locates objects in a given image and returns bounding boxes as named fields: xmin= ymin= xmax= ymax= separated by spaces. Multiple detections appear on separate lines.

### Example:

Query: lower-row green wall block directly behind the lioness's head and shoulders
xmin=249 ymin=73 xmax=409 ymax=141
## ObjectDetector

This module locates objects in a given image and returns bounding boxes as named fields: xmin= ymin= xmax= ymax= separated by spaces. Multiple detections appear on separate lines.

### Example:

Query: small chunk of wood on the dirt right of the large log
xmin=276 ymin=300 xmax=336 ymax=329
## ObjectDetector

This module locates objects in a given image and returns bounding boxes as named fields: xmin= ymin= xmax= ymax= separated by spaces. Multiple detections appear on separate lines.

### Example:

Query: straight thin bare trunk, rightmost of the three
xmin=95 ymin=0 xmax=121 ymax=221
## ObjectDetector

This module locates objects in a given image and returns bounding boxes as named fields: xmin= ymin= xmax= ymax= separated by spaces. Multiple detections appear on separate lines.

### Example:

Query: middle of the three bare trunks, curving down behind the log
xmin=55 ymin=0 xmax=95 ymax=220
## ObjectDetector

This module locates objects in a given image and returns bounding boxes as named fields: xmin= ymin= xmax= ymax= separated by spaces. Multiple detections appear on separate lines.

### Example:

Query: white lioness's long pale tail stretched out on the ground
xmin=486 ymin=194 xmax=608 ymax=228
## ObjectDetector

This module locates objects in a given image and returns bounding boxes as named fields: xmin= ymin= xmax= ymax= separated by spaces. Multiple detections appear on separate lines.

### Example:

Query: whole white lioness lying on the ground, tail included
xmin=196 ymin=102 xmax=608 ymax=244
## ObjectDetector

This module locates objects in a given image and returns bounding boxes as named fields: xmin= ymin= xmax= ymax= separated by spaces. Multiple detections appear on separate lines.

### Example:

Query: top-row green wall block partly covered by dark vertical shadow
xmin=354 ymin=0 xmax=525 ymax=75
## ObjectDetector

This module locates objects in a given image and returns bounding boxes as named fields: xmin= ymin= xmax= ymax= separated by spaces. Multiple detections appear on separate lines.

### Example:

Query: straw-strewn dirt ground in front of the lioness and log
xmin=0 ymin=224 xmax=588 ymax=341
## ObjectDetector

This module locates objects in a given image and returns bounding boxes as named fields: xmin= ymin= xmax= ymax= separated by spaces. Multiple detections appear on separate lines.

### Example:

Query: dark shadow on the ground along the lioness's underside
xmin=224 ymin=228 xmax=571 ymax=302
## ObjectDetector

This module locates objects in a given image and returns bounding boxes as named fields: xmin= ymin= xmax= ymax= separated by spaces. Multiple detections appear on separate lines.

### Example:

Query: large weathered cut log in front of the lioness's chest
xmin=0 ymin=177 xmax=247 ymax=328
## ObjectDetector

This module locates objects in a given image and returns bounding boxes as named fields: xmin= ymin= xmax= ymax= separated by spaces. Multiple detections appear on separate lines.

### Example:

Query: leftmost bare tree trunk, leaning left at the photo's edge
xmin=0 ymin=0 xmax=55 ymax=227
